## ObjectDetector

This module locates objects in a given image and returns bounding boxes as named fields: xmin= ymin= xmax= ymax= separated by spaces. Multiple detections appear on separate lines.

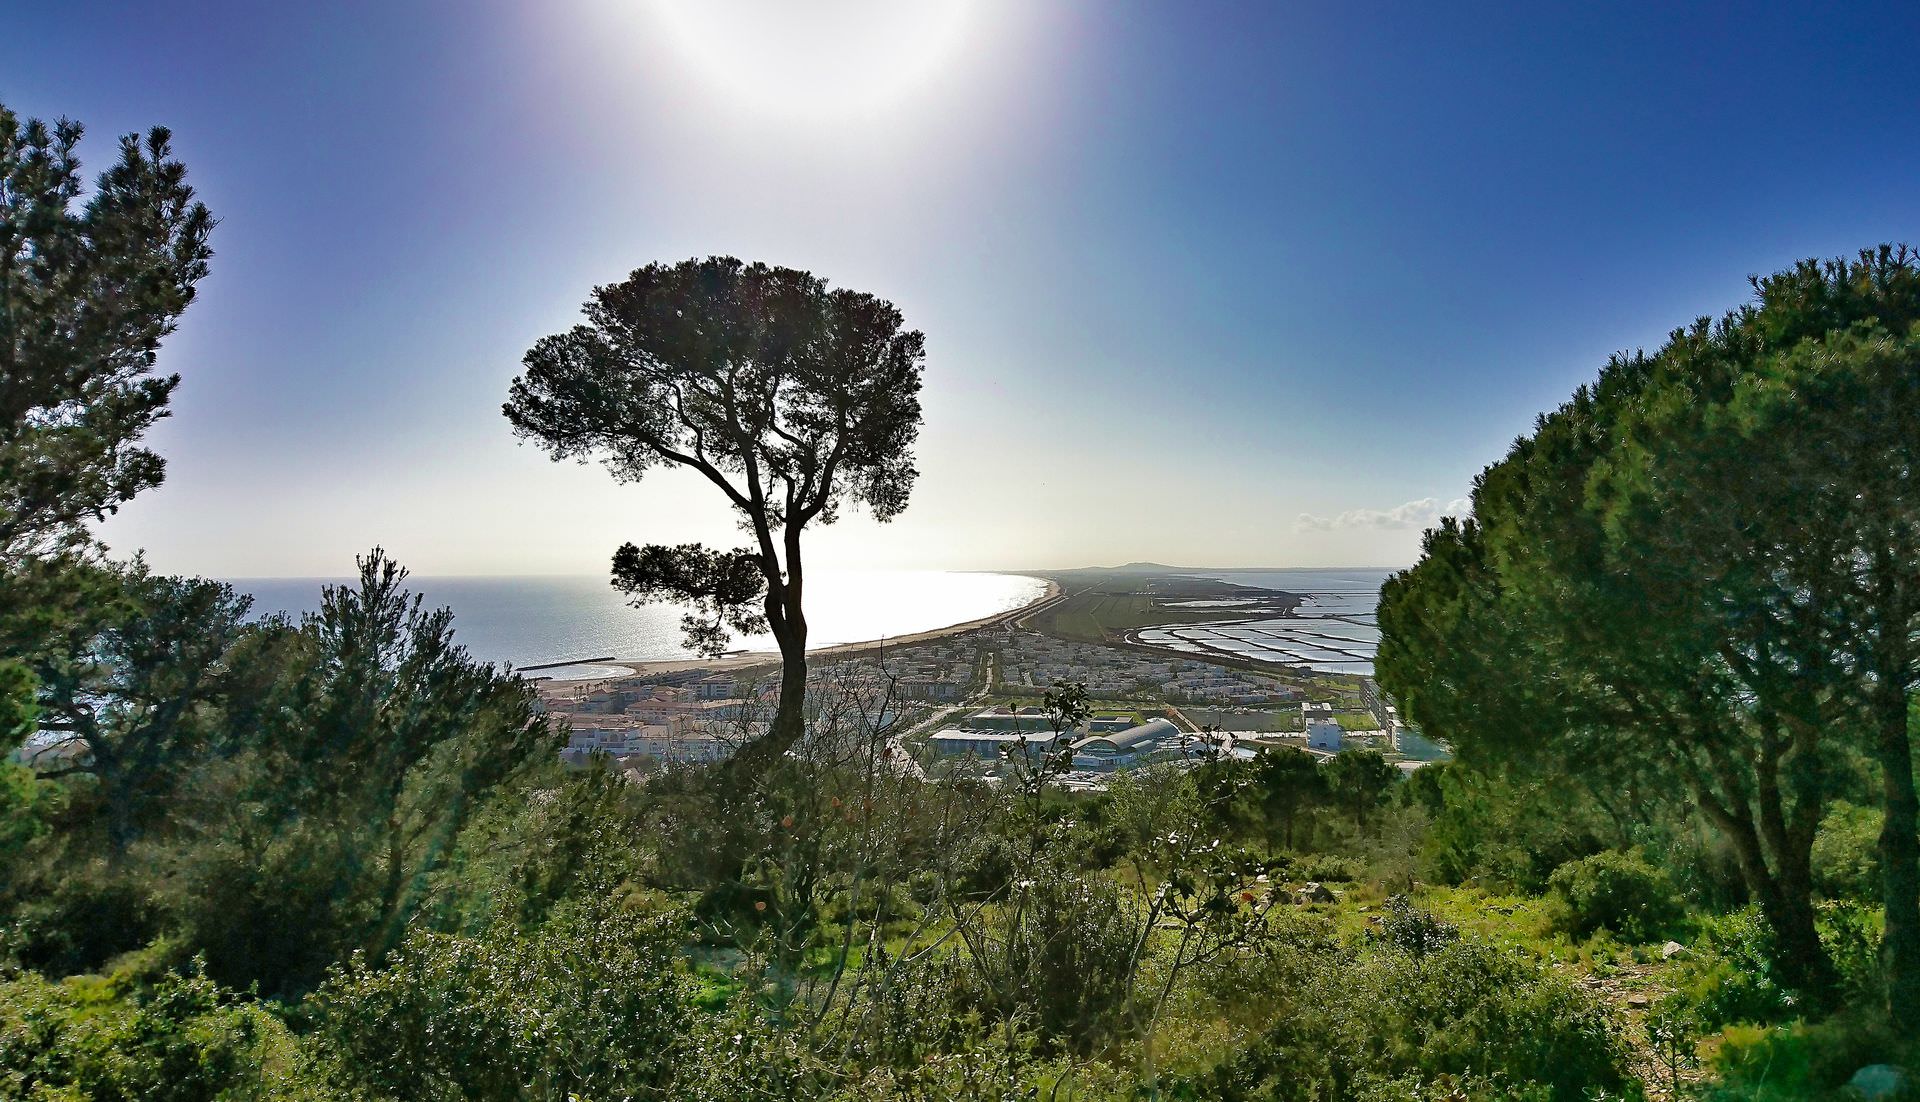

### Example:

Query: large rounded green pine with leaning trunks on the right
xmin=1379 ymin=248 xmax=1920 ymax=1029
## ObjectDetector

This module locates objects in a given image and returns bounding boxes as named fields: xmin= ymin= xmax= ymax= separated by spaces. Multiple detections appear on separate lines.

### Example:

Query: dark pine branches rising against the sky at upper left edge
xmin=0 ymin=106 xmax=213 ymax=559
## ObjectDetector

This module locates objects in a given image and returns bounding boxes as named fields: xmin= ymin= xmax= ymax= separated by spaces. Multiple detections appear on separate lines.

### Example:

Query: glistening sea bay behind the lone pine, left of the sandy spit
xmin=241 ymin=570 xmax=1046 ymax=678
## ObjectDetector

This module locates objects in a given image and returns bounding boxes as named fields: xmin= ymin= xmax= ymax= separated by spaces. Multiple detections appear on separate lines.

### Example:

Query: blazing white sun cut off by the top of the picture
xmin=639 ymin=0 xmax=993 ymax=121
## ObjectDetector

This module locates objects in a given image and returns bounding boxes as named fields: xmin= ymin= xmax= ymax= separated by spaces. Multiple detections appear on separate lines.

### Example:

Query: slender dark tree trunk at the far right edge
xmin=1874 ymin=682 xmax=1920 ymax=1033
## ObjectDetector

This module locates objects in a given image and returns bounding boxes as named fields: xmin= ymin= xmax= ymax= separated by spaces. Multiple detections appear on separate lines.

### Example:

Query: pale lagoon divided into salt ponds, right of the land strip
xmin=1139 ymin=568 xmax=1392 ymax=678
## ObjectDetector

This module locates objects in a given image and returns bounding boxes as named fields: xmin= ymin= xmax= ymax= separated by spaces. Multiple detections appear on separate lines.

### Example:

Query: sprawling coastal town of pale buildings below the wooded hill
xmin=536 ymin=578 xmax=1448 ymax=791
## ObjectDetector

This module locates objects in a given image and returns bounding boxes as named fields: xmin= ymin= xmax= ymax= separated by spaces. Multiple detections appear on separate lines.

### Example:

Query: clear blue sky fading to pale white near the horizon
xmin=0 ymin=0 xmax=1920 ymax=578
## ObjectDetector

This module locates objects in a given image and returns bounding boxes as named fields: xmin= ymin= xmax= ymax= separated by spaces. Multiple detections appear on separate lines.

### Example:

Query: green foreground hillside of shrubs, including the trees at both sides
xmin=0 ymin=101 xmax=1920 ymax=1102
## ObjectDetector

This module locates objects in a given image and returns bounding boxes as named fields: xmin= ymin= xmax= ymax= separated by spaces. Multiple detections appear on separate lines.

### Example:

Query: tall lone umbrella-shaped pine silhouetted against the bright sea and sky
xmin=505 ymin=257 xmax=925 ymax=772
